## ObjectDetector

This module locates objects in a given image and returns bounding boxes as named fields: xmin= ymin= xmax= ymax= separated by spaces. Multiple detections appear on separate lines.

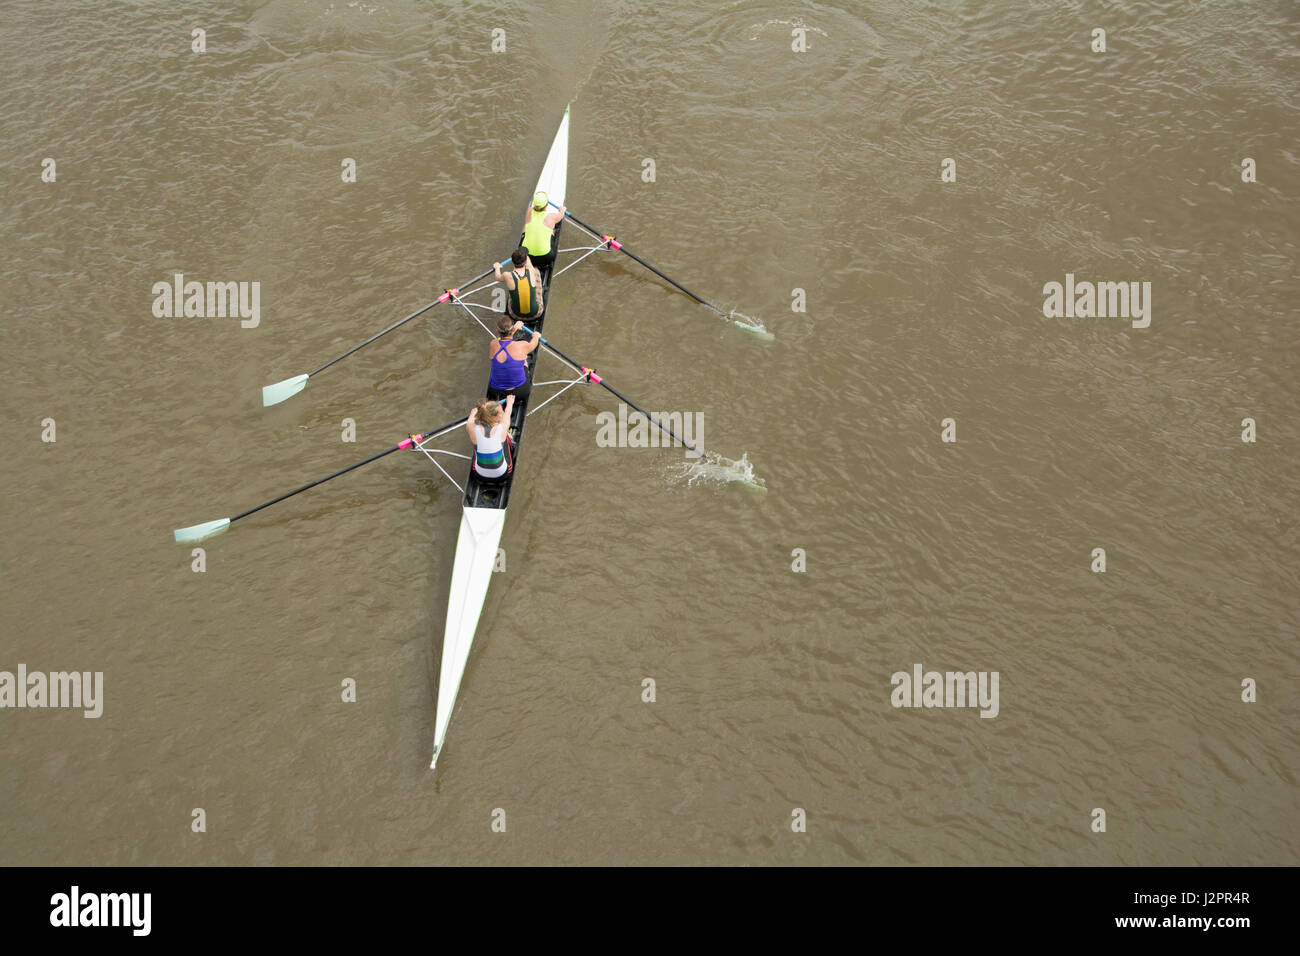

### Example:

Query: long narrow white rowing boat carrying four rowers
xmin=429 ymin=107 xmax=569 ymax=769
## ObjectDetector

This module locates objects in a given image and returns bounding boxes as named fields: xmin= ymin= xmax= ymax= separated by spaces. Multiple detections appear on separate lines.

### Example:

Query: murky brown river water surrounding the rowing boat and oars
xmin=0 ymin=0 xmax=1300 ymax=865
